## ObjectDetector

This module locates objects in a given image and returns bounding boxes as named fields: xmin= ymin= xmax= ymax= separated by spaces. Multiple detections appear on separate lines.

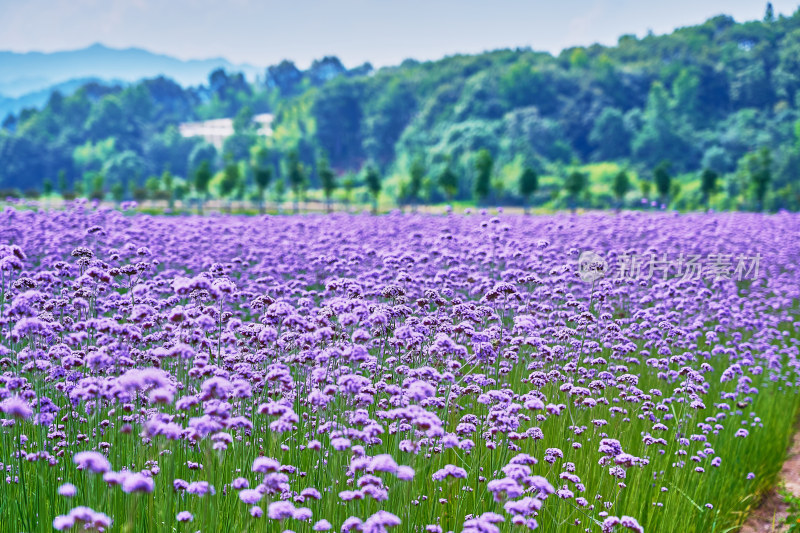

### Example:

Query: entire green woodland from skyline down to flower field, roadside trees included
xmin=0 ymin=6 xmax=800 ymax=210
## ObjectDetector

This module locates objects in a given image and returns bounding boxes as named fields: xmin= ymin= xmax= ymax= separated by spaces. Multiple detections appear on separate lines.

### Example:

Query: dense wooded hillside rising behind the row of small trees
xmin=0 ymin=6 xmax=800 ymax=208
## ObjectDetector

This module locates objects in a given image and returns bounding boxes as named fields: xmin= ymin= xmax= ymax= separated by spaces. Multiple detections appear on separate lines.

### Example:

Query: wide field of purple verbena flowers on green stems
xmin=0 ymin=204 xmax=800 ymax=533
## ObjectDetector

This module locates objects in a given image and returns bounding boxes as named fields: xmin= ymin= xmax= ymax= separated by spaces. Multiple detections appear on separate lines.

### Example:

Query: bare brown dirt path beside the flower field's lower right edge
xmin=740 ymin=424 xmax=800 ymax=533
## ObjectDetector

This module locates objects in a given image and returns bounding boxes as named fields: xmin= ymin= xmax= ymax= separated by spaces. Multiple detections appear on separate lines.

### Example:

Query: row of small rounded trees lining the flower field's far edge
xmin=17 ymin=141 xmax=780 ymax=214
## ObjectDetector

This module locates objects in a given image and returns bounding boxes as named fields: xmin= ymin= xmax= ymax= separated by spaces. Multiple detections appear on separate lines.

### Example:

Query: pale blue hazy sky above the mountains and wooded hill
xmin=0 ymin=0 xmax=800 ymax=67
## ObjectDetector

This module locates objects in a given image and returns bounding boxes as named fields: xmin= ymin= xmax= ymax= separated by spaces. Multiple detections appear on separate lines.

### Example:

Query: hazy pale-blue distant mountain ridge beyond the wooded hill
xmin=0 ymin=44 xmax=261 ymax=96
